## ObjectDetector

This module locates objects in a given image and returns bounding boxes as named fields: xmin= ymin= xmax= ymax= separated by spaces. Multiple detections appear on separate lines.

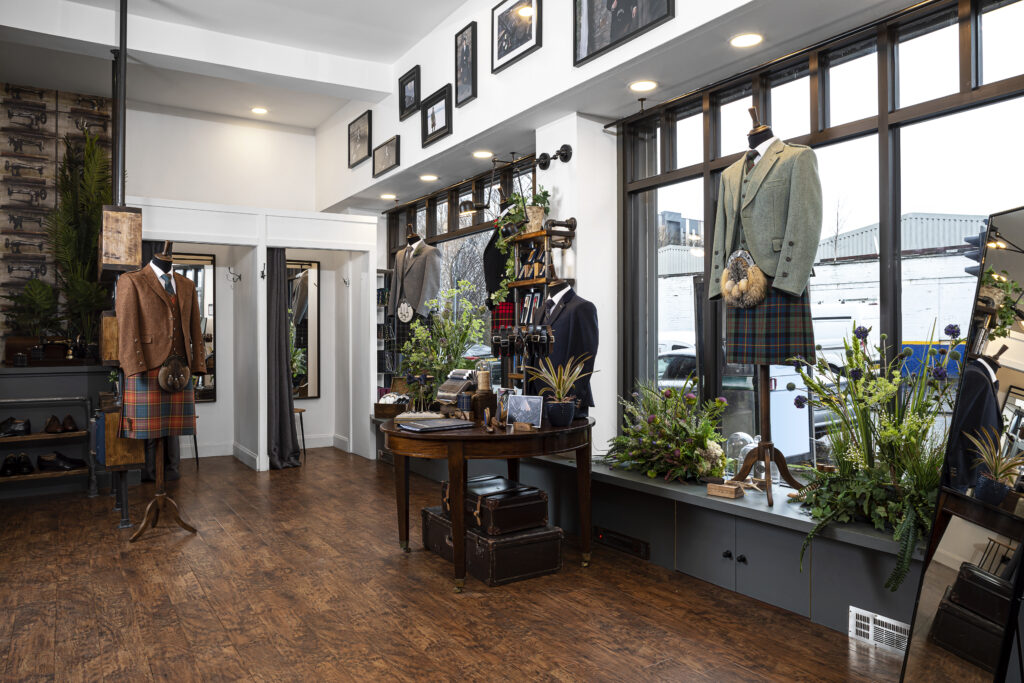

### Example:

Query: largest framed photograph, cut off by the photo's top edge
xmin=572 ymin=0 xmax=676 ymax=67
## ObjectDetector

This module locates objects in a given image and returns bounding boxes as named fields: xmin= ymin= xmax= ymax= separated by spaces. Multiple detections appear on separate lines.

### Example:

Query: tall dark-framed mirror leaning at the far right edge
xmin=903 ymin=208 xmax=1024 ymax=681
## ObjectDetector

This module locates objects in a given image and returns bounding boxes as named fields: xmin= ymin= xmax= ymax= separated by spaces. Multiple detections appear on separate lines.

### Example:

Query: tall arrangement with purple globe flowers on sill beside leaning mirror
xmin=788 ymin=325 xmax=963 ymax=591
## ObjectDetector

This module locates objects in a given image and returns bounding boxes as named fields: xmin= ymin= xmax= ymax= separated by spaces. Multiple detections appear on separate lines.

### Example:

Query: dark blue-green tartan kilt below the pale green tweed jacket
xmin=725 ymin=283 xmax=814 ymax=366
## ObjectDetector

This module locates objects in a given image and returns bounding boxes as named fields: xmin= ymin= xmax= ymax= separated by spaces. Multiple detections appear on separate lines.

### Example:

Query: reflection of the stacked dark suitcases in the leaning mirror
xmin=928 ymin=562 xmax=1013 ymax=671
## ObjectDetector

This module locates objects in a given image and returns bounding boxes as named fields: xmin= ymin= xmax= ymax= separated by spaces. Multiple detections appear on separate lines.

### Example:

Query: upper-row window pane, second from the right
xmin=896 ymin=9 xmax=959 ymax=108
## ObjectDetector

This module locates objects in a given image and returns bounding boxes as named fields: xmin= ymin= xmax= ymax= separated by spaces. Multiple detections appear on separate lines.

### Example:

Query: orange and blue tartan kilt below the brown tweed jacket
xmin=121 ymin=368 xmax=196 ymax=438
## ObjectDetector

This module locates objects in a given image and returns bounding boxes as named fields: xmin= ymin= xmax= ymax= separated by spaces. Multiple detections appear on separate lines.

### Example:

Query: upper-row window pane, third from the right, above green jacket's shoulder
xmin=825 ymin=39 xmax=879 ymax=126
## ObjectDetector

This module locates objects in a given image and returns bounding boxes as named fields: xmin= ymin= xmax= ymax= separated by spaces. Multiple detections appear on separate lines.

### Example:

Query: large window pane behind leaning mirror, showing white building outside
xmin=900 ymin=98 xmax=1024 ymax=358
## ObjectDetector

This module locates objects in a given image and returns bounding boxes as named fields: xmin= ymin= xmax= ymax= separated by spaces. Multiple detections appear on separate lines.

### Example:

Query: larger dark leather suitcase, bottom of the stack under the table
xmin=422 ymin=507 xmax=562 ymax=586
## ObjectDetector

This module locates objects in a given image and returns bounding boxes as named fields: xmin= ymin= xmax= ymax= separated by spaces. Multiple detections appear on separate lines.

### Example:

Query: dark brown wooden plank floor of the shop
xmin=0 ymin=449 xmax=900 ymax=683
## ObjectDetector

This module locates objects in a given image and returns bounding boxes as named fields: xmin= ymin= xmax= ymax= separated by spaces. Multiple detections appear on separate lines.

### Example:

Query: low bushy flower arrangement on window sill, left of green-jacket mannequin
xmin=605 ymin=380 xmax=728 ymax=481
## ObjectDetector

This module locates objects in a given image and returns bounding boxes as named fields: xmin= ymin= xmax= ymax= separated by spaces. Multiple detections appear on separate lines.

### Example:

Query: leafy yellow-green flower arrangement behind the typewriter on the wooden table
xmin=401 ymin=280 xmax=484 ymax=411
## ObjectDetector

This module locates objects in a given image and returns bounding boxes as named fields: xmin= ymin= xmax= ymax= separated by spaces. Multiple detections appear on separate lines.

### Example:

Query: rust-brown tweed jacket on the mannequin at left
xmin=116 ymin=263 xmax=206 ymax=376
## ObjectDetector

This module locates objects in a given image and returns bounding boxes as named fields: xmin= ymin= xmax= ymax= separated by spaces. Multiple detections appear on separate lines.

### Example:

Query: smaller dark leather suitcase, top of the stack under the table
xmin=441 ymin=474 xmax=548 ymax=536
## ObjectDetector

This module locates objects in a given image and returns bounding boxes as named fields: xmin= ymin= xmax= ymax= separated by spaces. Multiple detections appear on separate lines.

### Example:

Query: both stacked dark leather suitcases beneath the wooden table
xmin=422 ymin=475 xmax=562 ymax=586
